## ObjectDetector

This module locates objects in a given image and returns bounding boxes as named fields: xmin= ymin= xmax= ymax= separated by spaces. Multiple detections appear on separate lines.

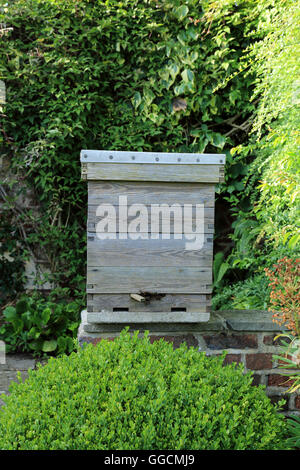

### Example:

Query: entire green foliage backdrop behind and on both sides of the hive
xmin=0 ymin=0 xmax=299 ymax=322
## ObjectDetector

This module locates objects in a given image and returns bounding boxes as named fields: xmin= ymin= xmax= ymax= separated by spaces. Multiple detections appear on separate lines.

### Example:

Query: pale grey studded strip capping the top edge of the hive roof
xmin=80 ymin=150 xmax=226 ymax=165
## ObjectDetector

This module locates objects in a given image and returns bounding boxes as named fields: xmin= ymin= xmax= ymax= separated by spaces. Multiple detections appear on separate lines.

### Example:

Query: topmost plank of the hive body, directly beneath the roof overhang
xmin=88 ymin=181 xmax=215 ymax=208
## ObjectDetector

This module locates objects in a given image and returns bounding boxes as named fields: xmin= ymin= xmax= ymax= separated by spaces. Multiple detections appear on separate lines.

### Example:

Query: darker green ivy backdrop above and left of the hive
xmin=0 ymin=0 xmax=262 ymax=302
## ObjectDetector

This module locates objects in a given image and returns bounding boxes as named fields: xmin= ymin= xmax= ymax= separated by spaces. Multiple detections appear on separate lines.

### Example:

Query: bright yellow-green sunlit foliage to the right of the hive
xmin=213 ymin=0 xmax=300 ymax=300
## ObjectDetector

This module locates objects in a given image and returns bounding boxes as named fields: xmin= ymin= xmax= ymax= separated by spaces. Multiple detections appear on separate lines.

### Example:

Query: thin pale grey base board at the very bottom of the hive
xmin=87 ymin=310 xmax=210 ymax=325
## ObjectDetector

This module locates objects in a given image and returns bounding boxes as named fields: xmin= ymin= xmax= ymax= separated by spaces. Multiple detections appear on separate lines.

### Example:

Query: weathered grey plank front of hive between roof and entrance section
xmin=87 ymin=182 xmax=214 ymax=294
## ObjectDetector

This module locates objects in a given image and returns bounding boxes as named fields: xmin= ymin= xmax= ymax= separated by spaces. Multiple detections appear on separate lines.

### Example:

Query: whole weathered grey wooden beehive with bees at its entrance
xmin=81 ymin=150 xmax=225 ymax=324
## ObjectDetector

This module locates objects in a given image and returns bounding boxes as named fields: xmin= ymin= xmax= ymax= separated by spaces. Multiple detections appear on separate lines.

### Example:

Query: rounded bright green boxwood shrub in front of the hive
xmin=0 ymin=330 xmax=286 ymax=450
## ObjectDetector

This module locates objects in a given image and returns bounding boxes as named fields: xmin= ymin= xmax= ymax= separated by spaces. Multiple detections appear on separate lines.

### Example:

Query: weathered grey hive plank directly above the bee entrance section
xmin=87 ymin=266 xmax=212 ymax=294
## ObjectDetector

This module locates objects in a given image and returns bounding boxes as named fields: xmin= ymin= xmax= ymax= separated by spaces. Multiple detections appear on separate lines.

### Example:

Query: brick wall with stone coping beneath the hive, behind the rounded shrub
xmin=78 ymin=310 xmax=300 ymax=415
